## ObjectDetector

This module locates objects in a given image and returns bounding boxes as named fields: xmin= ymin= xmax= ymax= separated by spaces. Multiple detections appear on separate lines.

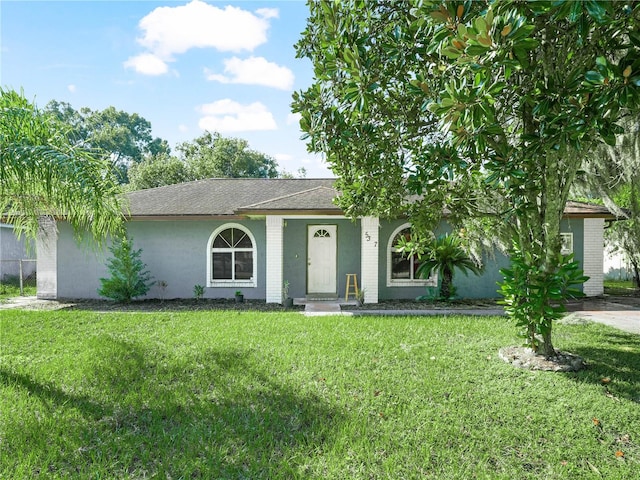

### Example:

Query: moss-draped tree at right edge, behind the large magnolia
xmin=577 ymin=118 xmax=640 ymax=289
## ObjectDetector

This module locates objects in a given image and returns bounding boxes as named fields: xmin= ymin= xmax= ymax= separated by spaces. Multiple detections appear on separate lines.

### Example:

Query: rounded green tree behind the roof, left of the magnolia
xmin=176 ymin=131 xmax=278 ymax=180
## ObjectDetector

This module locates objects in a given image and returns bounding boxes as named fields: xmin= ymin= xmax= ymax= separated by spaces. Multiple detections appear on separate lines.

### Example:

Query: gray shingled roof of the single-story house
xmin=127 ymin=178 xmax=613 ymax=218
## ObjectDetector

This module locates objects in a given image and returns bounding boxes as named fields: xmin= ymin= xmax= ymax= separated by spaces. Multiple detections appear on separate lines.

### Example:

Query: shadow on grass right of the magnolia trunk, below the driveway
xmin=570 ymin=329 xmax=640 ymax=403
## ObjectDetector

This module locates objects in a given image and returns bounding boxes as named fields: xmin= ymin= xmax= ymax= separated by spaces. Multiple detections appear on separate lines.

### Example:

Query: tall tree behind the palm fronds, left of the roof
xmin=45 ymin=100 xmax=170 ymax=183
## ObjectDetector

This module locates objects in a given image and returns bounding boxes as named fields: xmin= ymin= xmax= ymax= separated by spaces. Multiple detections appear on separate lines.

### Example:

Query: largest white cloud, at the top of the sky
xmin=138 ymin=0 xmax=277 ymax=60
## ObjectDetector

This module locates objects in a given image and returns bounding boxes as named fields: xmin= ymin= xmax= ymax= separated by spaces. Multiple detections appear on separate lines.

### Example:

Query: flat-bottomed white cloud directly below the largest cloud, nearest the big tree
xmin=205 ymin=57 xmax=295 ymax=90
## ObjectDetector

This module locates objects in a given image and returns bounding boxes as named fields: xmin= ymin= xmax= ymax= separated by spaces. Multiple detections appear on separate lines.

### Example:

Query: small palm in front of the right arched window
xmin=416 ymin=234 xmax=480 ymax=300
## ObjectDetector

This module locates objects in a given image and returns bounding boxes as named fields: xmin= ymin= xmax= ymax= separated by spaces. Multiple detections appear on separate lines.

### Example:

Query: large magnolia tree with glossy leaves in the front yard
xmin=293 ymin=0 xmax=640 ymax=356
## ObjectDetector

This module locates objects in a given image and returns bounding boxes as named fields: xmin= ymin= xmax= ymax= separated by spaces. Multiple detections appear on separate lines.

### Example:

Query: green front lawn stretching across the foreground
xmin=0 ymin=310 xmax=640 ymax=479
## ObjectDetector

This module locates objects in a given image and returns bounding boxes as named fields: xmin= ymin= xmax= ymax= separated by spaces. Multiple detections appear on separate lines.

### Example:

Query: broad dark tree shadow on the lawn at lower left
xmin=0 ymin=337 xmax=341 ymax=478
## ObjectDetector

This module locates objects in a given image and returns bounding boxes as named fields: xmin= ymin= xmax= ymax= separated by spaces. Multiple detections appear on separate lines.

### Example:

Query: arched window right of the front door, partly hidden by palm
xmin=387 ymin=223 xmax=438 ymax=287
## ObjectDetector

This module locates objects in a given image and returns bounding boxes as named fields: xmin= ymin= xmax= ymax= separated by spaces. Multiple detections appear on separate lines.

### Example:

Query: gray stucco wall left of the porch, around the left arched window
xmin=57 ymin=220 xmax=266 ymax=299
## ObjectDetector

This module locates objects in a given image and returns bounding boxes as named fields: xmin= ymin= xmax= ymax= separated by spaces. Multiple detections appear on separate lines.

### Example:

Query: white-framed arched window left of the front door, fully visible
xmin=207 ymin=224 xmax=256 ymax=287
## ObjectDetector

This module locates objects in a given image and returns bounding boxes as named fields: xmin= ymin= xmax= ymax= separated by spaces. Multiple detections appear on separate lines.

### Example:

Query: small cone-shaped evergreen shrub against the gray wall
xmin=98 ymin=237 xmax=154 ymax=303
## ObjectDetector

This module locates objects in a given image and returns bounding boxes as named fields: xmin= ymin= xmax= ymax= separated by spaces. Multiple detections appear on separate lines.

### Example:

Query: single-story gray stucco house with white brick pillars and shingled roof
xmin=38 ymin=178 xmax=610 ymax=303
